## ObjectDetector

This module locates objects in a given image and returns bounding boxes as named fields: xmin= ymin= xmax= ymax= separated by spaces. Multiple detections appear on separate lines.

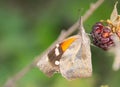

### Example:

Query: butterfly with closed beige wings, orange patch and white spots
xmin=37 ymin=18 xmax=92 ymax=79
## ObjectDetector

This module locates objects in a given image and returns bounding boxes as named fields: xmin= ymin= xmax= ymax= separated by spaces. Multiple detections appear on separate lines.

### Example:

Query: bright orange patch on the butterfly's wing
xmin=60 ymin=37 xmax=77 ymax=52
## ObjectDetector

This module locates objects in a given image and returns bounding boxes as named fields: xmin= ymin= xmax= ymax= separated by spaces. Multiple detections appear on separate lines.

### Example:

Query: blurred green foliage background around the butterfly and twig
xmin=0 ymin=0 xmax=120 ymax=87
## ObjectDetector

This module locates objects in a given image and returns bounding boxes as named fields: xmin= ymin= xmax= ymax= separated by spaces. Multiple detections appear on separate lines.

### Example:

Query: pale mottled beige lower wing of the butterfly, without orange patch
xmin=60 ymin=35 xmax=92 ymax=79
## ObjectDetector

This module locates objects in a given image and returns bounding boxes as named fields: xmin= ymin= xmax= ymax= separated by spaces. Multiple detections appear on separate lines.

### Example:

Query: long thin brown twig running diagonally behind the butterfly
xmin=4 ymin=0 xmax=104 ymax=87
